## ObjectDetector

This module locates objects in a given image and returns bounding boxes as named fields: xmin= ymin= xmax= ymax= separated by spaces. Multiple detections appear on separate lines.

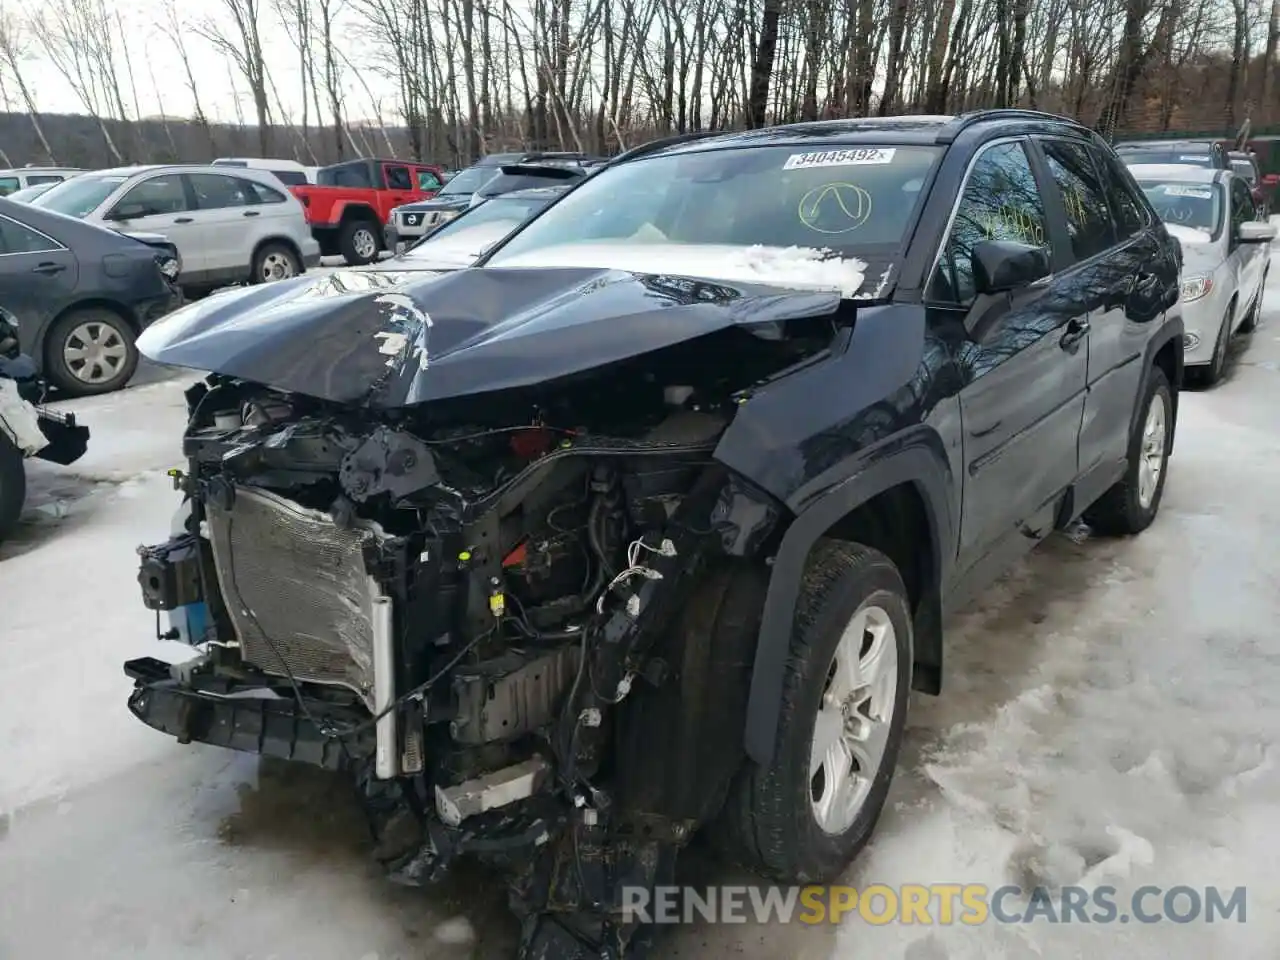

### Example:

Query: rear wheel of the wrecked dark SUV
xmin=1084 ymin=366 xmax=1174 ymax=536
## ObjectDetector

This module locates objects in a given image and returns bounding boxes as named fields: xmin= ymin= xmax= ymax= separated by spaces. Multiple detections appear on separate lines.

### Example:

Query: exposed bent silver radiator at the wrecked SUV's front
xmin=206 ymin=486 xmax=381 ymax=708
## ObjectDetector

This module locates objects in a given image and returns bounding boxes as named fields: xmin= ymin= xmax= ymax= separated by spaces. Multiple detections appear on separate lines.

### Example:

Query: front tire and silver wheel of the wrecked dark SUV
xmin=714 ymin=540 xmax=911 ymax=883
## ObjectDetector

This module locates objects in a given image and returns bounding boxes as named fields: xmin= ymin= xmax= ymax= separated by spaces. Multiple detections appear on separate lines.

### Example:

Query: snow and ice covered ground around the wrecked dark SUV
xmin=0 ymin=270 xmax=1280 ymax=960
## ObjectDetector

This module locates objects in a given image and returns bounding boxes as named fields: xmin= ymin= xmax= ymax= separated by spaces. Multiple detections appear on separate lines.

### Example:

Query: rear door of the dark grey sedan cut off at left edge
xmin=0 ymin=215 xmax=78 ymax=362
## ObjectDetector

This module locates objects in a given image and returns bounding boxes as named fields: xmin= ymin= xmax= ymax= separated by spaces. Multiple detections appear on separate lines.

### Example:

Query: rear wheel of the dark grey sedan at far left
xmin=45 ymin=307 xmax=138 ymax=397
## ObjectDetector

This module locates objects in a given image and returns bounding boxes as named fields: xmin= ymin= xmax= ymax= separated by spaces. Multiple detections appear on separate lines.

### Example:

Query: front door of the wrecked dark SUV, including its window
xmin=929 ymin=140 xmax=1088 ymax=583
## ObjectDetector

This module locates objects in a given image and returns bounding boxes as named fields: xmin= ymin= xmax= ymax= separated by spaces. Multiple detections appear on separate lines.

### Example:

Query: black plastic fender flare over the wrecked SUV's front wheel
xmin=744 ymin=431 xmax=955 ymax=765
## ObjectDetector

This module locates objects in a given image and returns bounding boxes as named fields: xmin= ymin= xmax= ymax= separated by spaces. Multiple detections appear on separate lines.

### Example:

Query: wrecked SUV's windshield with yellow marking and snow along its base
xmin=486 ymin=145 xmax=941 ymax=287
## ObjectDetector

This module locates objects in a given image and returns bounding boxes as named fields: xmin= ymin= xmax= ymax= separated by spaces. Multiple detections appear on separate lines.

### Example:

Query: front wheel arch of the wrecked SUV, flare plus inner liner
xmin=744 ymin=442 xmax=955 ymax=764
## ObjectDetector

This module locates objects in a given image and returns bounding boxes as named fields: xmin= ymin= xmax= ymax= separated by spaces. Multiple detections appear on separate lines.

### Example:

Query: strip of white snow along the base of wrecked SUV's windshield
xmin=494 ymin=242 xmax=867 ymax=297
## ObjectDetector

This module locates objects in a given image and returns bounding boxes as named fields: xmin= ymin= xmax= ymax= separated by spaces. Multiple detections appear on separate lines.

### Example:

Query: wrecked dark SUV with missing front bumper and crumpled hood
xmin=125 ymin=110 xmax=1183 ymax=960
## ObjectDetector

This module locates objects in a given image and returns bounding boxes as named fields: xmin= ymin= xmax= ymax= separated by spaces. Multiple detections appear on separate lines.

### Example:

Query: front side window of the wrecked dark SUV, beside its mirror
xmin=929 ymin=143 xmax=1048 ymax=305
